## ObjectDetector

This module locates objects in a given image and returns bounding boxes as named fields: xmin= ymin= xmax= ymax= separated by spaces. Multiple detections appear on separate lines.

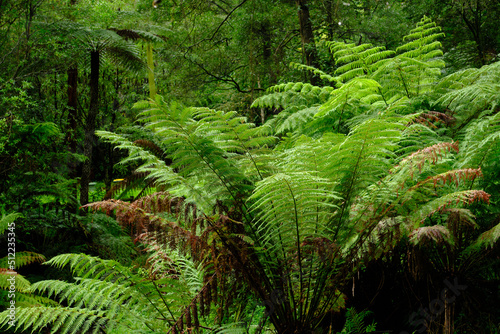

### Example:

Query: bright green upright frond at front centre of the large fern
xmin=249 ymin=173 xmax=340 ymax=256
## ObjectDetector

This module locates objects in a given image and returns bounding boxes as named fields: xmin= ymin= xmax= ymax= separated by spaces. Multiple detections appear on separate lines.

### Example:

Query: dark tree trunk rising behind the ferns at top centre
xmin=295 ymin=0 xmax=318 ymax=85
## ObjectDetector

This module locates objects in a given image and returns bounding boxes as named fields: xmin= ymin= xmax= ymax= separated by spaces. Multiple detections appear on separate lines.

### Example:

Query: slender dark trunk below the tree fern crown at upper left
xmin=80 ymin=50 xmax=99 ymax=205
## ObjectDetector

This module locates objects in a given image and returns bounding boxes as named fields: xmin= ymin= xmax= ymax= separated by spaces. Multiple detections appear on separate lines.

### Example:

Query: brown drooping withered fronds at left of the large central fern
xmin=86 ymin=193 xmax=258 ymax=330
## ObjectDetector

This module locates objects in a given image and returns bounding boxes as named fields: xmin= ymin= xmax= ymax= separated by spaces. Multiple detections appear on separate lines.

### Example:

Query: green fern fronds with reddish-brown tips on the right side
xmin=351 ymin=142 xmax=490 ymax=259
